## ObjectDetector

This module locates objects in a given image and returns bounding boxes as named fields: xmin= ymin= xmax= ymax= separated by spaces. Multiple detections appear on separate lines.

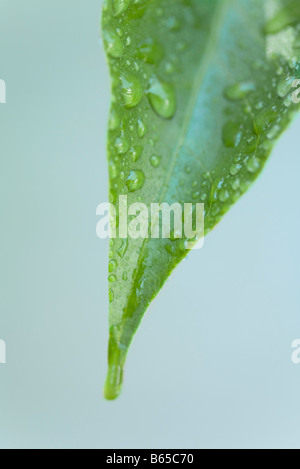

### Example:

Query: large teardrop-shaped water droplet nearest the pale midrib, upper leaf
xmin=147 ymin=78 xmax=176 ymax=119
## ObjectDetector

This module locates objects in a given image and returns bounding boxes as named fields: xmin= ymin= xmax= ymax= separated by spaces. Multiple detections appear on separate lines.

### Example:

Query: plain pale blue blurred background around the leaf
xmin=0 ymin=0 xmax=300 ymax=449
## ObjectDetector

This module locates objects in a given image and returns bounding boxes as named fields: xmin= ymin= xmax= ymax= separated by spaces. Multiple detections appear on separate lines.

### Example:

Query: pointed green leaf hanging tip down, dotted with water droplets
xmin=103 ymin=0 xmax=300 ymax=399
